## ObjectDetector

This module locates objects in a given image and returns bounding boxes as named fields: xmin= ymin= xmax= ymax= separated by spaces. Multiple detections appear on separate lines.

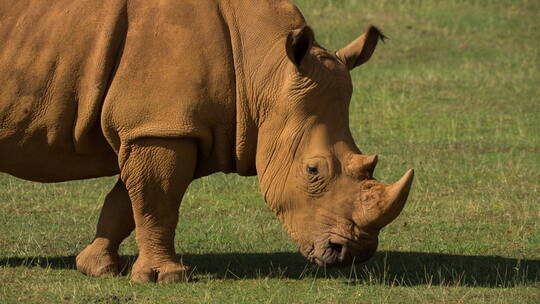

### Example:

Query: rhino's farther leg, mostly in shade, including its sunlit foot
xmin=76 ymin=180 xmax=135 ymax=277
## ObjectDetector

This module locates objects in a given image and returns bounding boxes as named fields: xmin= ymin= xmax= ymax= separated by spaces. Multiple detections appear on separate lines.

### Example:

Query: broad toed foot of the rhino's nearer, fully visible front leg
xmin=131 ymin=256 xmax=191 ymax=283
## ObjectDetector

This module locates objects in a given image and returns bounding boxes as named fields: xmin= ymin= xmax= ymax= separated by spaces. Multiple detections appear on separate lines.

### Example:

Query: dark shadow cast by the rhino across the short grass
xmin=0 ymin=251 xmax=540 ymax=288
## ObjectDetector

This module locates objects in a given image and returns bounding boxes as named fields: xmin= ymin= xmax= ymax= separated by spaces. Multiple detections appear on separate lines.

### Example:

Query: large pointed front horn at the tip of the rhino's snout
xmin=378 ymin=169 xmax=414 ymax=228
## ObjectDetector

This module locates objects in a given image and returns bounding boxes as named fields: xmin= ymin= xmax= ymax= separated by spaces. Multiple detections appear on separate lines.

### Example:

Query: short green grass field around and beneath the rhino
xmin=0 ymin=0 xmax=540 ymax=303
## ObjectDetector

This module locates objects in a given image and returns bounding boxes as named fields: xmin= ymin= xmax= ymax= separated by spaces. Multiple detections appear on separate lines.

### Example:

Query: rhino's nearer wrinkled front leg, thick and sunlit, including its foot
xmin=120 ymin=138 xmax=197 ymax=282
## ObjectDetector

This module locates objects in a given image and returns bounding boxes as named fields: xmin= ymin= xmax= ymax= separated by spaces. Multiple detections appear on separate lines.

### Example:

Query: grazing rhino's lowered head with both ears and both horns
xmin=256 ymin=26 xmax=414 ymax=265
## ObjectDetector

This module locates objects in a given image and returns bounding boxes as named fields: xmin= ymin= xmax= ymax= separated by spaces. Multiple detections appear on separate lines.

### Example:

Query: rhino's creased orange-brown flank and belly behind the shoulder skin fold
xmin=0 ymin=0 xmax=126 ymax=181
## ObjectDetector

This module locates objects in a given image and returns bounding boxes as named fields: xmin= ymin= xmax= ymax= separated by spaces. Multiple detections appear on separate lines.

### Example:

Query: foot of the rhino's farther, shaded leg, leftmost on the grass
xmin=76 ymin=244 xmax=127 ymax=277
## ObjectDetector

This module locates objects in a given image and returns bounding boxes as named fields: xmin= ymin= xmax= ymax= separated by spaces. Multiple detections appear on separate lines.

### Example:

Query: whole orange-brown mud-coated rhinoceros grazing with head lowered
xmin=0 ymin=0 xmax=413 ymax=282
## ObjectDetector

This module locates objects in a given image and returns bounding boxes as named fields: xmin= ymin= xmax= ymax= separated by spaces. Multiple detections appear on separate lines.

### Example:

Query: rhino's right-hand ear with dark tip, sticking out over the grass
xmin=336 ymin=26 xmax=387 ymax=70
